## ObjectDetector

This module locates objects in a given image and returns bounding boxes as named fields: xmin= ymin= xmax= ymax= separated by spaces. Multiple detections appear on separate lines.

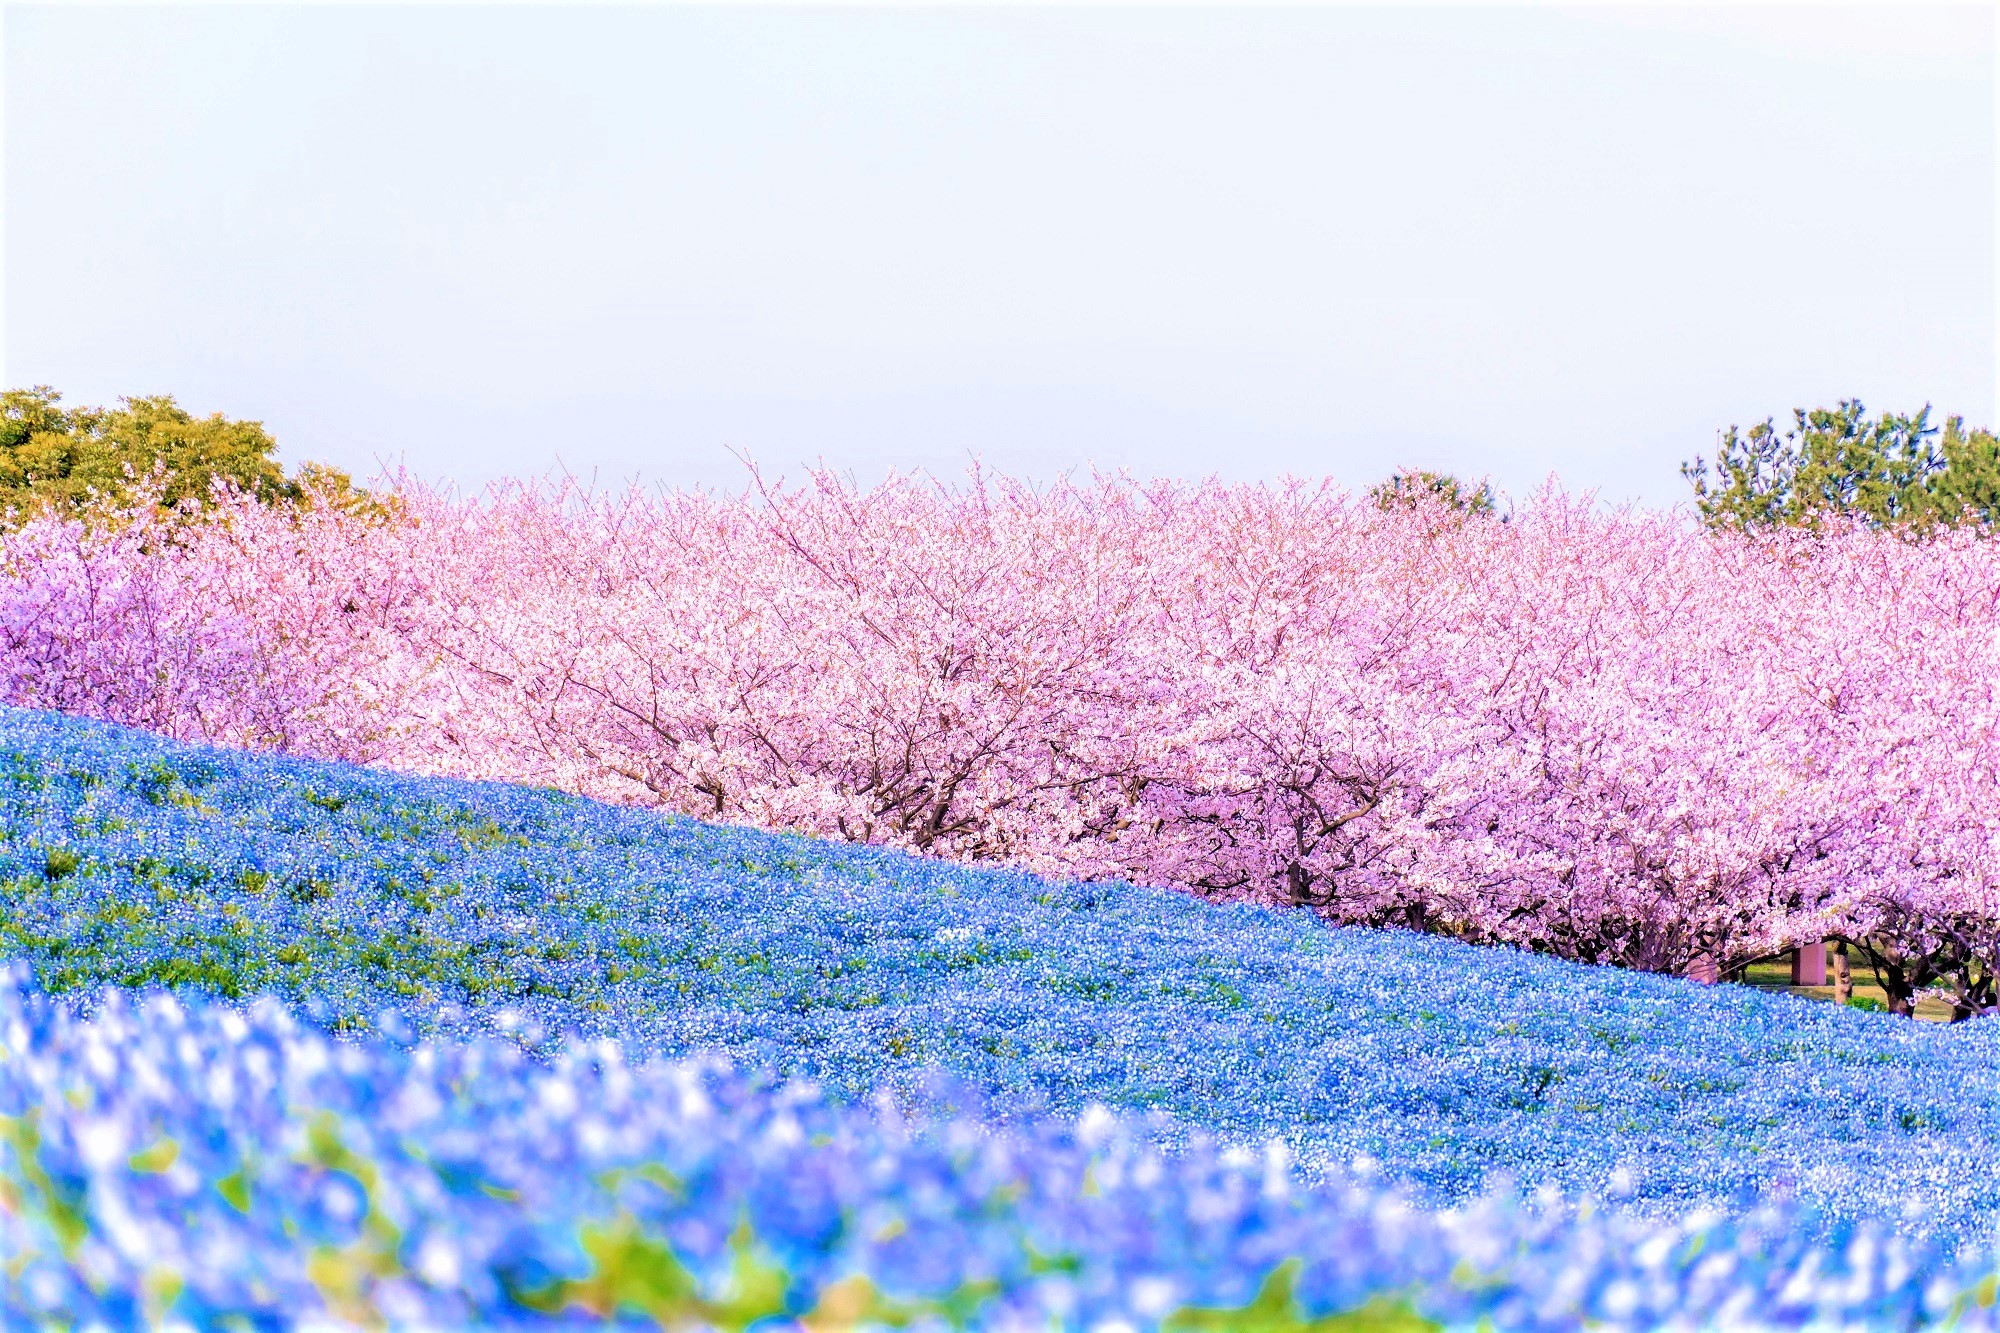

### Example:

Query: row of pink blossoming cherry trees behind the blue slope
xmin=0 ymin=476 xmax=2000 ymax=1015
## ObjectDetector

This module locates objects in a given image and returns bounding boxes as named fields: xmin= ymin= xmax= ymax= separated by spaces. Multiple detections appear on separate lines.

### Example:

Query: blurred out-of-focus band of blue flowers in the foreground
xmin=0 ymin=967 xmax=1994 ymax=1329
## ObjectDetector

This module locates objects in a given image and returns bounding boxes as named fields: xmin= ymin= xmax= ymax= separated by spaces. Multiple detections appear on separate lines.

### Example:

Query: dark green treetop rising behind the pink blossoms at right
xmin=1680 ymin=398 xmax=2000 ymax=532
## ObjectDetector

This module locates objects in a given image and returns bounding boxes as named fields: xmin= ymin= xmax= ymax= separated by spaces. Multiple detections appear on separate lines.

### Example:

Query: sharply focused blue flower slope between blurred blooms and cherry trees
xmin=0 ymin=711 xmax=2000 ymax=1281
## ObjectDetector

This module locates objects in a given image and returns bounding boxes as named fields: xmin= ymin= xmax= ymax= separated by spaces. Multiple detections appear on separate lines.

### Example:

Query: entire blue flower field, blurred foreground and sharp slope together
xmin=11 ymin=711 xmax=2000 ymax=1331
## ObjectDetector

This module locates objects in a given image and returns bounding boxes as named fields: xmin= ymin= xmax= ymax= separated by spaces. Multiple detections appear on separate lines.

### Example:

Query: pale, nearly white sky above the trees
xmin=0 ymin=4 xmax=2000 ymax=506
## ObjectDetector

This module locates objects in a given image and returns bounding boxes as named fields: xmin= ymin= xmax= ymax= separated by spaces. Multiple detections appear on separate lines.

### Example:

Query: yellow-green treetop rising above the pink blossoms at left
xmin=0 ymin=384 xmax=368 ymax=520
